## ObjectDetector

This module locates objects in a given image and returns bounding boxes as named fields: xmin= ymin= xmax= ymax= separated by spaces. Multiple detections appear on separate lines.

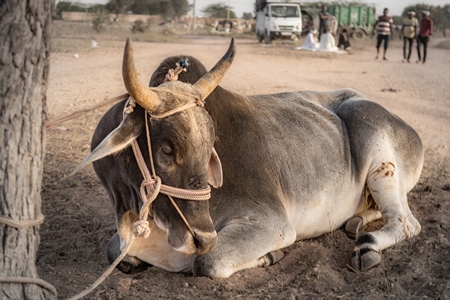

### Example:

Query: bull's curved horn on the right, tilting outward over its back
xmin=194 ymin=38 xmax=236 ymax=100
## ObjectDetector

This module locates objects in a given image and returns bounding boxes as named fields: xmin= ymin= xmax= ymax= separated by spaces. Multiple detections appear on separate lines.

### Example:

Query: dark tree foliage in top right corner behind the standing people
xmin=402 ymin=3 xmax=450 ymax=36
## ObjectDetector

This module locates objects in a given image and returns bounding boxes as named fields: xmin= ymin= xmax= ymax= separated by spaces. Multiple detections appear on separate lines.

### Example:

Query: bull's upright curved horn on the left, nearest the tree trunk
xmin=122 ymin=39 xmax=160 ymax=112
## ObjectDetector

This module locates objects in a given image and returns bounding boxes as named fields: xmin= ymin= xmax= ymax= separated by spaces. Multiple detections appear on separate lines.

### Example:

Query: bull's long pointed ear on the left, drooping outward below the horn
xmin=66 ymin=113 xmax=142 ymax=178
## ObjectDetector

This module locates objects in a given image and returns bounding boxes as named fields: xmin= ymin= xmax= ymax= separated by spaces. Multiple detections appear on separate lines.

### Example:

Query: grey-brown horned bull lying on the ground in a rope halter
xmin=75 ymin=39 xmax=423 ymax=278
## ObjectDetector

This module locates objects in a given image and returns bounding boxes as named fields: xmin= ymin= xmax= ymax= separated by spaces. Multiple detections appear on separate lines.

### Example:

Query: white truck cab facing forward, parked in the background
xmin=255 ymin=0 xmax=302 ymax=44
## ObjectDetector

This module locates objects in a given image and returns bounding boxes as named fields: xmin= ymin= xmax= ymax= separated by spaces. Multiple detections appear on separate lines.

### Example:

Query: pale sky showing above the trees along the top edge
xmin=72 ymin=0 xmax=450 ymax=17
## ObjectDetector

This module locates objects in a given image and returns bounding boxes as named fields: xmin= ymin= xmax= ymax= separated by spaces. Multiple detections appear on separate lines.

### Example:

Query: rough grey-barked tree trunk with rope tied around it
xmin=0 ymin=0 xmax=56 ymax=299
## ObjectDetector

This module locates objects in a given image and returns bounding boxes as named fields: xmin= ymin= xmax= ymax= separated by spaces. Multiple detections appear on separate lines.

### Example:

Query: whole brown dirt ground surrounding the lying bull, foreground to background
xmin=37 ymin=23 xmax=450 ymax=299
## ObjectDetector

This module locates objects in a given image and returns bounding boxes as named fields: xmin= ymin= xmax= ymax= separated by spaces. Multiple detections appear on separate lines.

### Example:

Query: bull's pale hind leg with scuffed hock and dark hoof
xmin=351 ymin=157 xmax=421 ymax=271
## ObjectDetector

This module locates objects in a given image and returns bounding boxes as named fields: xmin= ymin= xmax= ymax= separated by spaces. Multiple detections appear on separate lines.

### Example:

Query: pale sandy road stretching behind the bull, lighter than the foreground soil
xmin=48 ymin=38 xmax=450 ymax=151
